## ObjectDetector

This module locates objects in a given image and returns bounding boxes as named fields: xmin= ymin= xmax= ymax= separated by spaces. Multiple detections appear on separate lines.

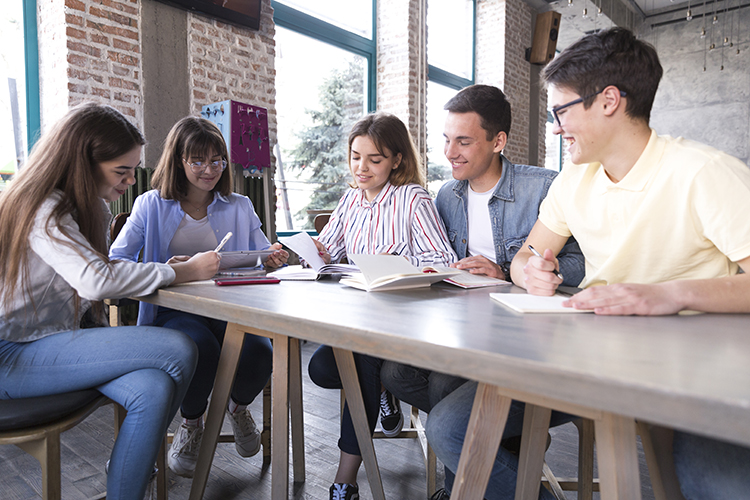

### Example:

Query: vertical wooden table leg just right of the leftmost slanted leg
xmin=271 ymin=335 xmax=289 ymax=500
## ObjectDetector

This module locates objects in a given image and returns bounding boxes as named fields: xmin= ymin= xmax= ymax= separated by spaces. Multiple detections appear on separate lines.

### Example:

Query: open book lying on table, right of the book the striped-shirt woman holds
xmin=341 ymin=254 xmax=461 ymax=292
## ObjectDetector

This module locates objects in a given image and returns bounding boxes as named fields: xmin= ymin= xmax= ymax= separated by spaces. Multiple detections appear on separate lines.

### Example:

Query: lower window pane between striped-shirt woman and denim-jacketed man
xmin=427 ymin=81 xmax=458 ymax=197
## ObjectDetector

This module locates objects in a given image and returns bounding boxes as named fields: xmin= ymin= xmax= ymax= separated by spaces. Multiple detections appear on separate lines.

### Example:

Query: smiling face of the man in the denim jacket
xmin=443 ymin=111 xmax=507 ymax=192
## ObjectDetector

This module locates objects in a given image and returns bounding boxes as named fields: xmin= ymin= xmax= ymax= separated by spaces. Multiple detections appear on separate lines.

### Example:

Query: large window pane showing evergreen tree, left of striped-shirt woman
xmin=275 ymin=26 xmax=367 ymax=231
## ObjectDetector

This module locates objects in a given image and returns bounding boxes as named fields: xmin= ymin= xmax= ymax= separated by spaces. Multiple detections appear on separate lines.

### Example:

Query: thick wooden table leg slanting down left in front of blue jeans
xmin=451 ymin=383 xmax=516 ymax=500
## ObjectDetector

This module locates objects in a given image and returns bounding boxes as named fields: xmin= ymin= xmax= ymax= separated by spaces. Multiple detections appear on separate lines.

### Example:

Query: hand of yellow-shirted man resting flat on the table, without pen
xmin=563 ymin=282 xmax=684 ymax=316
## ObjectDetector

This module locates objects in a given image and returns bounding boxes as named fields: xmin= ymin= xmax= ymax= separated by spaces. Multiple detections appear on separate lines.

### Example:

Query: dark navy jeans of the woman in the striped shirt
xmin=307 ymin=345 xmax=383 ymax=456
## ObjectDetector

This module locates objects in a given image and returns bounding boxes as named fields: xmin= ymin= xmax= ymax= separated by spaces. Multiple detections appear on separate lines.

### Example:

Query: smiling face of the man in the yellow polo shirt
xmin=549 ymin=85 xmax=603 ymax=165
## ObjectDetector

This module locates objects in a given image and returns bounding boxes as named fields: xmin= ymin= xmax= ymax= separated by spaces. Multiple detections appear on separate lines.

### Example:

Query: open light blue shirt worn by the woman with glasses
xmin=109 ymin=189 xmax=271 ymax=325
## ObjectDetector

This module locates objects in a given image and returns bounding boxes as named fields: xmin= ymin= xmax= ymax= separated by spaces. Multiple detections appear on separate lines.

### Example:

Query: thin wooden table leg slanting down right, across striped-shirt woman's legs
xmin=333 ymin=347 xmax=385 ymax=500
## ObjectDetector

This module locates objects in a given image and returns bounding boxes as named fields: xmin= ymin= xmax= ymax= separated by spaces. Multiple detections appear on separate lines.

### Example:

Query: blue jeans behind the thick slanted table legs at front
xmin=425 ymin=382 xmax=576 ymax=500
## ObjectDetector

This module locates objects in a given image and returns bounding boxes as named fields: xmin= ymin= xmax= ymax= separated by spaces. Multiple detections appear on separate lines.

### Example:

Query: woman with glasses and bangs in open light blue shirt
xmin=109 ymin=116 xmax=288 ymax=477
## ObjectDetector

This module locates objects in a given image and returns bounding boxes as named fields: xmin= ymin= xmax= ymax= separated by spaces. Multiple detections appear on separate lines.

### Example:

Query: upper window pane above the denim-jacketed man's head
xmin=427 ymin=0 xmax=474 ymax=80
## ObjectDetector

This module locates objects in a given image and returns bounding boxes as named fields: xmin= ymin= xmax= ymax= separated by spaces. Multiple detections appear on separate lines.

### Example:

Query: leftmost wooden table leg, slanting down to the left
xmin=190 ymin=323 xmax=245 ymax=500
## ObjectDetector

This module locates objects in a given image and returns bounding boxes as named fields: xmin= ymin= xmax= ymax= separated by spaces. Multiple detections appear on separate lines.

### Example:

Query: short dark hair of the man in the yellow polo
xmin=542 ymin=28 xmax=663 ymax=123
